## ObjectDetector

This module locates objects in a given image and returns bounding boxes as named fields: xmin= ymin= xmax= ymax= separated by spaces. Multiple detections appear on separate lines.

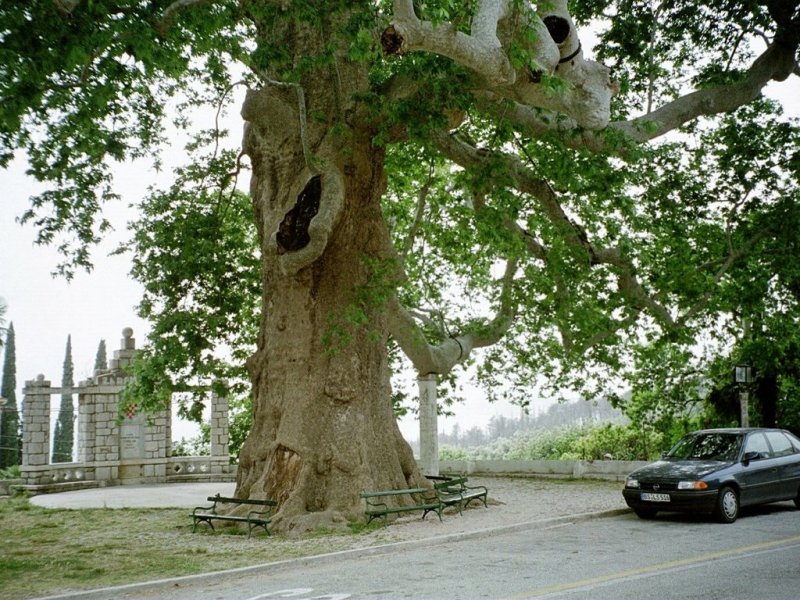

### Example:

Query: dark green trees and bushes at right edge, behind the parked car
xmin=620 ymin=100 xmax=800 ymax=439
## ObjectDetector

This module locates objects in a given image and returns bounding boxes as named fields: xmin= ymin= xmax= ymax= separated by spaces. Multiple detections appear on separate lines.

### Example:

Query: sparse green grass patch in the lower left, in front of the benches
xmin=0 ymin=497 xmax=362 ymax=599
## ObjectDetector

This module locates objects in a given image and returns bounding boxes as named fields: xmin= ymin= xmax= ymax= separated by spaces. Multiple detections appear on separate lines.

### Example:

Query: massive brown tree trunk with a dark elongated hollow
xmin=236 ymin=14 xmax=423 ymax=530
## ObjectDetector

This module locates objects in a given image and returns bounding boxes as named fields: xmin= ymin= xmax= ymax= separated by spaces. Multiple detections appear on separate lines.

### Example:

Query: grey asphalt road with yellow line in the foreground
xmin=42 ymin=503 xmax=800 ymax=600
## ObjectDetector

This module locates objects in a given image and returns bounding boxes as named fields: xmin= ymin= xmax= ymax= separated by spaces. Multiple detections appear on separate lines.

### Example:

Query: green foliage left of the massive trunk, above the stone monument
xmin=125 ymin=143 xmax=260 ymax=421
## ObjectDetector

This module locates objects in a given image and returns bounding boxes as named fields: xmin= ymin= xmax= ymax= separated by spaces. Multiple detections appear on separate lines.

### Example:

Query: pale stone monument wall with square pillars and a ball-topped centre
xmin=17 ymin=328 xmax=235 ymax=493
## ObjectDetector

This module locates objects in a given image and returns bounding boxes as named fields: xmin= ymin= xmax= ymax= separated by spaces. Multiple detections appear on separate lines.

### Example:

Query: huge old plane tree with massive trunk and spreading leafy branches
xmin=0 ymin=0 xmax=800 ymax=529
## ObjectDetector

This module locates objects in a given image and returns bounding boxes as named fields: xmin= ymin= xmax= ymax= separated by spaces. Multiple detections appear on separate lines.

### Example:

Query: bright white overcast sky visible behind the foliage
xmin=0 ymin=63 xmax=800 ymax=439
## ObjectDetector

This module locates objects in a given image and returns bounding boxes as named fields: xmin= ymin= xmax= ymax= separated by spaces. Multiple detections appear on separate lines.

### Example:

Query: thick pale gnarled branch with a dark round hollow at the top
xmin=388 ymin=0 xmax=617 ymax=129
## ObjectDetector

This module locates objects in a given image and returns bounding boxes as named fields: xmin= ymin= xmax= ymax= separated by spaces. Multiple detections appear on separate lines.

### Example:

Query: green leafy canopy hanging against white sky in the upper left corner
xmin=0 ymin=0 xmax=250 ymax=276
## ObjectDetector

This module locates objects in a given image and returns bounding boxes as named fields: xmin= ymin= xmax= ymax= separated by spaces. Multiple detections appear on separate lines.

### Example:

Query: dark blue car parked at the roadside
xmin=622 ymin=428 xmax=800 ymax=523
